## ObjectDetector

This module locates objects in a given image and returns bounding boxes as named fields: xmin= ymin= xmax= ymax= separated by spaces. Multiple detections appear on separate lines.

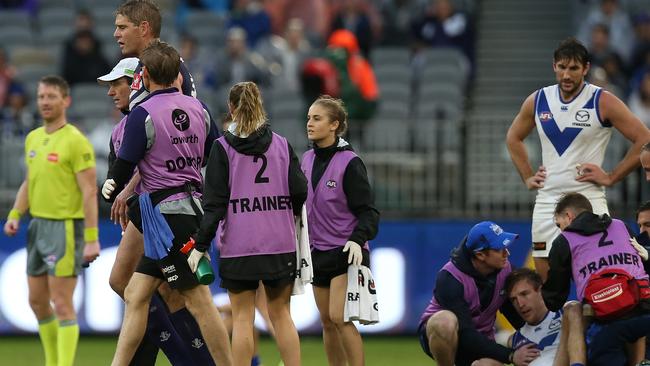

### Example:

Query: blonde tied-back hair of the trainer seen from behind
xmin=228 ymin=81 xmax=266 ymax=136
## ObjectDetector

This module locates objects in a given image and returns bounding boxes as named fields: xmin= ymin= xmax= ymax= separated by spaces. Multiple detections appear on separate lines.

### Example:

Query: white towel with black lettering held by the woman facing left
xmin=343 ymin=264 xmax=379 ymax=324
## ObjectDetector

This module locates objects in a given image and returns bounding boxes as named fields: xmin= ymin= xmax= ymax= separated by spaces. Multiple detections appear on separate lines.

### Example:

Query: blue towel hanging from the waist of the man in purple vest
xmin=139 ymin=193 xmax=174 ymax=259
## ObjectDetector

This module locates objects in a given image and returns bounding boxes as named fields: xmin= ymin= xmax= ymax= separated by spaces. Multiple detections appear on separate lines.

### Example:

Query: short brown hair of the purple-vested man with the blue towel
xmin=140 ymin=41 xmax=181 ymax=86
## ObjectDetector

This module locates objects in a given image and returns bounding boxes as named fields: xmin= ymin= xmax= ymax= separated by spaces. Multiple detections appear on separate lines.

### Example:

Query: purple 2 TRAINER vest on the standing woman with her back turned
xmin=217 ymin=133 xmax=296 ymax=258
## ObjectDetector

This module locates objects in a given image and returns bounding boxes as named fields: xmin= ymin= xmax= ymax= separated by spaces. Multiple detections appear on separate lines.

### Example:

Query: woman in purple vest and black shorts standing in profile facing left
xmin=302 ymin=95 xmax=379 ymax=366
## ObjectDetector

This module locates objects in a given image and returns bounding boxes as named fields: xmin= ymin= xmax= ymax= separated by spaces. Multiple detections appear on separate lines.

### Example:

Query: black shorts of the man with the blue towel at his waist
xmin=129 ymin=201 xmax=200 ymax=290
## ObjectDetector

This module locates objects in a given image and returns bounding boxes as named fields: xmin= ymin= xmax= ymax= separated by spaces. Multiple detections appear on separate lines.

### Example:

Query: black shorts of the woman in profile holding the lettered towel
xmin=311 ymin=247 xmax=370 ymax=287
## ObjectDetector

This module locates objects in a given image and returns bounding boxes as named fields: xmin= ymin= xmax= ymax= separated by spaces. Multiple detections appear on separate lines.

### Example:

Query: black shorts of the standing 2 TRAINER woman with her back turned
xmin=219 ymin=252 xmax=296 ymax=290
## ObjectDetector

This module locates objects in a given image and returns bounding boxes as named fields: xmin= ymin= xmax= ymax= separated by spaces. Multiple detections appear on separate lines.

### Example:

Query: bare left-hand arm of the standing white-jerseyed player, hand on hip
xmin=506 ymin=93 xmax=546 ymax=189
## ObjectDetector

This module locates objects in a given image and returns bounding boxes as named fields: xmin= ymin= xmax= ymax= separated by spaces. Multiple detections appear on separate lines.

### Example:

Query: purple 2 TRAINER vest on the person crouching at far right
xmin=562 ymin=219 xmax=648 ymax=300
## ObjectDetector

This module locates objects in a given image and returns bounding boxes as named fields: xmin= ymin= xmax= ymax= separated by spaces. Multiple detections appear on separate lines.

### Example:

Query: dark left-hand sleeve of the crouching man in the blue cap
xmin=434 ymin=271 xmax=512 ymax=363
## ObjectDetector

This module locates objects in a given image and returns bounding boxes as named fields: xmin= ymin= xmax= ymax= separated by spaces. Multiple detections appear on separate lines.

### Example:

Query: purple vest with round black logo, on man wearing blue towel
xmin=135 ymin=92 xmax=209 ymax=197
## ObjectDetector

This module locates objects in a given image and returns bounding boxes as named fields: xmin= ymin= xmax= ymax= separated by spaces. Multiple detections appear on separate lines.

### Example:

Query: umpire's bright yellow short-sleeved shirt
xmin=25 ymin=124 xmax=95 ymax=220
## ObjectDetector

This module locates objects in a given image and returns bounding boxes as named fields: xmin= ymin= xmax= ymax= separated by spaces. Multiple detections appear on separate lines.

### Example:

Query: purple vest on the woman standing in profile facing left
xmin=301 ymin=150 xmax=368 ymax=250
